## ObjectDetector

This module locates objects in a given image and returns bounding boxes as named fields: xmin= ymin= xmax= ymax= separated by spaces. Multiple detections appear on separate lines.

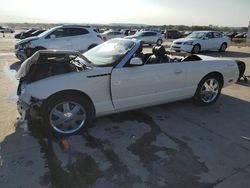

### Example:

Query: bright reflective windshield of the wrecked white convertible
xmin=83 ymin=39 xmax=135 ymax=66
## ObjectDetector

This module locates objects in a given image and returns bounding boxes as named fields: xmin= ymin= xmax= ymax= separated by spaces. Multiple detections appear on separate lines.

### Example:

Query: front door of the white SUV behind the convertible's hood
xmin=43 ymin=28 xmax=71 ymax=50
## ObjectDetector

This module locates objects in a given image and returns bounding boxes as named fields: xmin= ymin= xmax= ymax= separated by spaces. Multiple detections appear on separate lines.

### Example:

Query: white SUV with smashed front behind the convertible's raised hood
xmin=15 ymin=25 xmax=103 ymax=61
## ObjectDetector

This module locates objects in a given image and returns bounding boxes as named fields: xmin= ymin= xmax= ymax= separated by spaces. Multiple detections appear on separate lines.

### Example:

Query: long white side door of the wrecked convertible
xmin=111 ymin=63 xmax=186 ymax=109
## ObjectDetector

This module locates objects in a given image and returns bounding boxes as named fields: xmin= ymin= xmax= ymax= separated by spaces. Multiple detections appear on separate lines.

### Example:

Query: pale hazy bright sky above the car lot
xmin=0 ymin=0 xmax=250 ymax=27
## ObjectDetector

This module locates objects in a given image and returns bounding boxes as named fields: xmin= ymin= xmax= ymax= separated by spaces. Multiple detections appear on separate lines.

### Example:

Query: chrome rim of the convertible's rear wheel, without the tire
xmin=200 ymin=78 xmax=220 ymax=103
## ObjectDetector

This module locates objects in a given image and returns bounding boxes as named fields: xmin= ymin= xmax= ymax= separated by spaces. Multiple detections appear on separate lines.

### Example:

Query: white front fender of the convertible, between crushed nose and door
xmin=20 ymin=68 xmax=113 ymax=114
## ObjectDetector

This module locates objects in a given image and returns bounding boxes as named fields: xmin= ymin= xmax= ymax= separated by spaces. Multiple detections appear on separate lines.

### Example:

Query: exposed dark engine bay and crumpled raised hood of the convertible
xmin=16 ymin=51 xmax=87 ymax=83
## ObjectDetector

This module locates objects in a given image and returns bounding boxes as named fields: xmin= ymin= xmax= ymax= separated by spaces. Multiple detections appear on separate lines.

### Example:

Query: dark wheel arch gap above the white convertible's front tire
xmin=46 ymin=89 xmax=96 ymax=115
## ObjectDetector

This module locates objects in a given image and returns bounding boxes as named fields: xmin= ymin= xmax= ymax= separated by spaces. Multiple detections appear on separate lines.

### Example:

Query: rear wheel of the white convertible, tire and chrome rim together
xmin=194 ymin=75 xmax=223 ymax=106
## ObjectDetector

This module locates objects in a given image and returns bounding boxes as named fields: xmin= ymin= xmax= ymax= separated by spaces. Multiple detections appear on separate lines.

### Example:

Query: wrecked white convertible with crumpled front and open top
xmin=17 ymin=39 xmax=239 ymax=135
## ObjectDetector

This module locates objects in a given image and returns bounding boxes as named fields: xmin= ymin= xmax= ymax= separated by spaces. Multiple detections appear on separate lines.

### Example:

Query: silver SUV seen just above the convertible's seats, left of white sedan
xmin=125 ymin=31 xmax=163 ymax=45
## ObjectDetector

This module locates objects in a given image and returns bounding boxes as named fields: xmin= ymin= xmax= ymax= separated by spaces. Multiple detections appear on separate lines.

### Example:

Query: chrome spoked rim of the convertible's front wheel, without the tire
xmin=49 ymin=101 xmax=86 ymax=134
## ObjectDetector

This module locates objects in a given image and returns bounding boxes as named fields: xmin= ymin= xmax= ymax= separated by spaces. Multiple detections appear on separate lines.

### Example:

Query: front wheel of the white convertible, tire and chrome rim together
xmin=44 ymin=94 xmax=94 ymax=136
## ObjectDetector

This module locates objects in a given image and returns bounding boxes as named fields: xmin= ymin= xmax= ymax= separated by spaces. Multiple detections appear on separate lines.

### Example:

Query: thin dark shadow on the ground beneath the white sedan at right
xmin=200 ymin=51 xmax=250 ymax=58
